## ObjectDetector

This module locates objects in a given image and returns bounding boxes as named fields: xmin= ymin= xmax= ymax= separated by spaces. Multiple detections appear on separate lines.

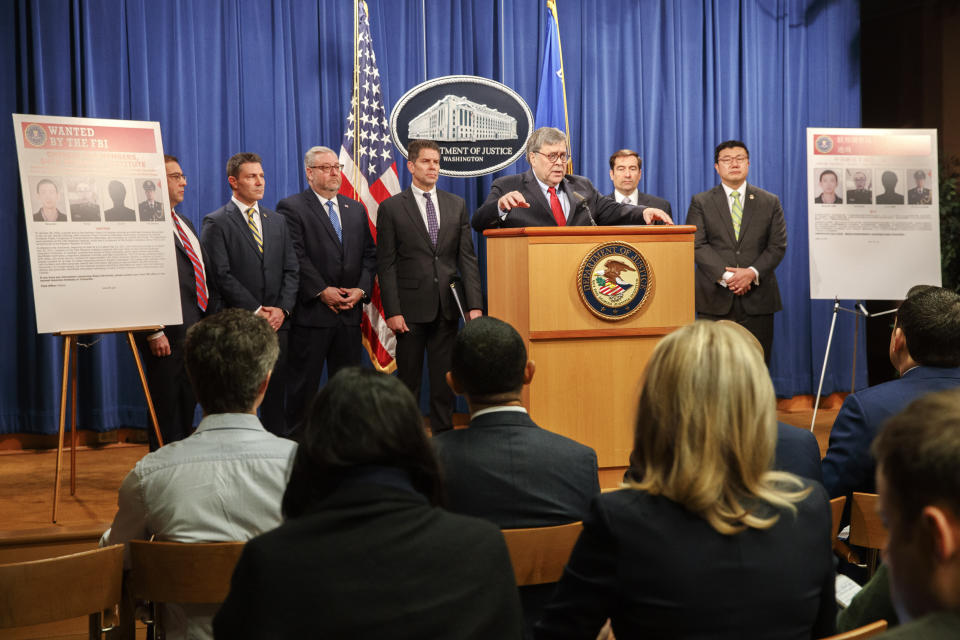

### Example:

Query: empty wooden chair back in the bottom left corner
xmin=0 ymin=544 xmax=123 ymax=638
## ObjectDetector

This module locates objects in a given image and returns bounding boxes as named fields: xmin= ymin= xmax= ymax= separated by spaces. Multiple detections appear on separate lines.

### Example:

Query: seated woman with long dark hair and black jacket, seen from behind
xmin=214 ymin=367 xmax=520 ymax=639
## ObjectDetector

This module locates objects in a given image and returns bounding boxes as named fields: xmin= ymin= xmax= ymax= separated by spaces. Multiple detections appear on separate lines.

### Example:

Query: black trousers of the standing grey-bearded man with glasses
xmin=287 ymin=323 xmax=361 ymax=432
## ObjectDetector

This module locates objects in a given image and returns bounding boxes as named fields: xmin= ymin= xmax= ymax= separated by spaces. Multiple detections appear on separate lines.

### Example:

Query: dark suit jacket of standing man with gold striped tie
xmin=200 ymin=200 xmax=299 ymax=313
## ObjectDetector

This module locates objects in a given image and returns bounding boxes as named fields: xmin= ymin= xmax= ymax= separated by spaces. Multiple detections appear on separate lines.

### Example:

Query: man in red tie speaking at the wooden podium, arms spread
xmin=470 ymin=127 xmax=673 ymax=231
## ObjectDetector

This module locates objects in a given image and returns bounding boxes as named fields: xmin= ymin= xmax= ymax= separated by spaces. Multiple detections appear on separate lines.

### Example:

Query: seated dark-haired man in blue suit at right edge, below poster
xmin=823 ymin=286 xmax=960 ymax=498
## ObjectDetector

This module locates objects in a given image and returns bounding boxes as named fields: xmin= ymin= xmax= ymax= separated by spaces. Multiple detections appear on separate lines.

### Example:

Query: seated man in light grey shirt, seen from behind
xmin=100 ymin=309 xmax=296 ymax=638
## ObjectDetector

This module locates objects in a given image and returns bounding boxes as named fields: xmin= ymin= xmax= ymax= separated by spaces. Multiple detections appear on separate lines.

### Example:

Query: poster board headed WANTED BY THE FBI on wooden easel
xmin=13 ymin=114 xmax=183 ymax=333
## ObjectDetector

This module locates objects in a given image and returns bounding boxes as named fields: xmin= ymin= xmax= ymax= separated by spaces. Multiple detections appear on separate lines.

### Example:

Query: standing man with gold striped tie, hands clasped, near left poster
xmin=200 ymin=153 xmax=299 ymax=436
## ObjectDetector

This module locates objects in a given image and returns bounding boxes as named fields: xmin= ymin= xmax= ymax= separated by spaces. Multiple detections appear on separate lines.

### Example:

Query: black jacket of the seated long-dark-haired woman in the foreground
xmin=213 ymin=484 xmax=520 ymax=640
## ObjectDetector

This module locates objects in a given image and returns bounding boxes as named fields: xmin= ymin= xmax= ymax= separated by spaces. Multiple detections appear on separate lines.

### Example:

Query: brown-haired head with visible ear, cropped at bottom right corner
xmin=872 ymin=389 xmax=960 ymax=640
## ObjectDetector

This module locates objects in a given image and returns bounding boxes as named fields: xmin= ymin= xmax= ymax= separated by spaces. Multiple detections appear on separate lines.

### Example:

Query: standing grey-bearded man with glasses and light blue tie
xmin=277 ymin=147 xmax=377 ymax=427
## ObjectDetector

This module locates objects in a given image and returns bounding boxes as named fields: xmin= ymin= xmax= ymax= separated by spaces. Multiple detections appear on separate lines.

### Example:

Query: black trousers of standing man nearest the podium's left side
xmin=397 ymin=313 xmax=460 ymax=433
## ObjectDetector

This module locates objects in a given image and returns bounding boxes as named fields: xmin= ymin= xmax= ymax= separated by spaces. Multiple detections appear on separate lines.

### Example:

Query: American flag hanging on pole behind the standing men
xmin=340 ymin=0 xmax=400 ymax=373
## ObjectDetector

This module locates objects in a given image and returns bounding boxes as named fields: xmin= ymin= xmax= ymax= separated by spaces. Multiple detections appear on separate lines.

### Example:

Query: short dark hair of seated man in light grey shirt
xmin=184 ymin=309 xmax=280 ymax=415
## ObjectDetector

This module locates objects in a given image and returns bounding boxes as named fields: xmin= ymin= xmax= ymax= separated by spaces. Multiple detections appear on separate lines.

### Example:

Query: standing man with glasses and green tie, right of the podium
xmin=687 ymin=140 xmax=787 ymax=364
